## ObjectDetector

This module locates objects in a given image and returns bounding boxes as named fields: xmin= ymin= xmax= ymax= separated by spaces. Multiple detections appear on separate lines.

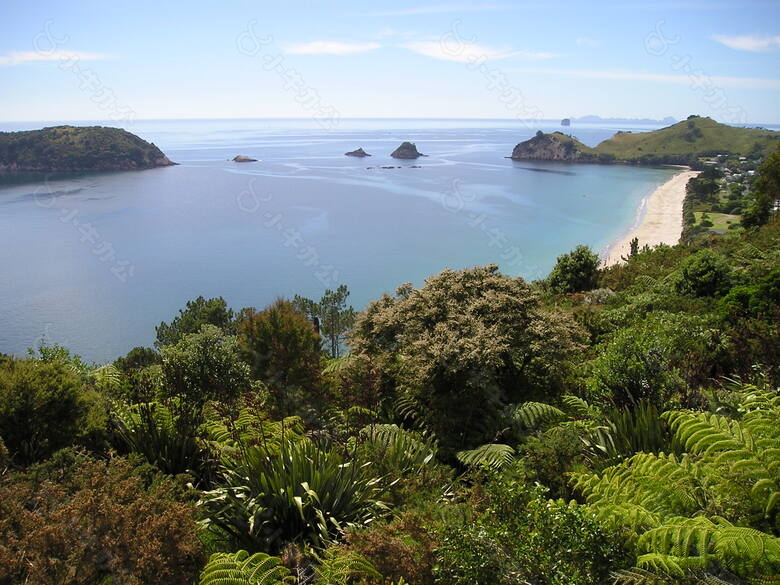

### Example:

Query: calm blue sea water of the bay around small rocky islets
xmin=0 ymin=120 xmax=673 ymax=361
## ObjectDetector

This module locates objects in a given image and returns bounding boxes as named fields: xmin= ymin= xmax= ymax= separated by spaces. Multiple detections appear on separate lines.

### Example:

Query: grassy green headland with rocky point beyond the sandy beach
xmin=510 ymin=116 xmax=780 ymax=165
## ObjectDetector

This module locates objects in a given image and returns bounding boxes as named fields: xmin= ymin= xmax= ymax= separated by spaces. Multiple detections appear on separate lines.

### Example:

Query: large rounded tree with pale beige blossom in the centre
xmin=351 ymin=264 xmax=581 ymax=454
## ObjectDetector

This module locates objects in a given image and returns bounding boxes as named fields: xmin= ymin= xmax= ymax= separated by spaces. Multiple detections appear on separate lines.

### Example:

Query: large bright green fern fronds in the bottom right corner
xmin=573 ymin=386 xmax=780 ymax=583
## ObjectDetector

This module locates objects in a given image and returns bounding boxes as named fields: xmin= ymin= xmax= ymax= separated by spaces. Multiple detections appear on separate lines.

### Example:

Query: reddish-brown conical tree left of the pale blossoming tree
xmin=238 ymin=299 xmax=322 ymax=412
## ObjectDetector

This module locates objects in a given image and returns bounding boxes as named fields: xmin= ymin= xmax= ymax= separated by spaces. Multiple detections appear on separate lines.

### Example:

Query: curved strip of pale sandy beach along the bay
xmin=604 ymin=169 xmax=699 ymax=266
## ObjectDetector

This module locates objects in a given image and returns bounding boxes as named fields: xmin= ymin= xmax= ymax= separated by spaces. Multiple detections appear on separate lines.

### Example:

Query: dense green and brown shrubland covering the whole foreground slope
xmin=0 ymin=157 xmax=780 ymax=585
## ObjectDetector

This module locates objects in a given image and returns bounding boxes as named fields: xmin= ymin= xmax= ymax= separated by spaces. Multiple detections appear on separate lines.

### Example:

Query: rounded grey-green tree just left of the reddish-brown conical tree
xmin=160 ymin=325 xmax=251 ymax=410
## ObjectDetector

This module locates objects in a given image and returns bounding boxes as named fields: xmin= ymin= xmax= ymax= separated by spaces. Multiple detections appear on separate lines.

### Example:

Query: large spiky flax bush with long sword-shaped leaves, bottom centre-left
xmin=200 ymin=439 xmax=386 ymax=551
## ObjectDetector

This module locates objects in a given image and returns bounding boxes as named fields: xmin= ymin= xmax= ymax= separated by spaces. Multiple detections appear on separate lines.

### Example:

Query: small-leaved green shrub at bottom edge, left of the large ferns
xmin=435 ymin=478 xmax=625 ymax=585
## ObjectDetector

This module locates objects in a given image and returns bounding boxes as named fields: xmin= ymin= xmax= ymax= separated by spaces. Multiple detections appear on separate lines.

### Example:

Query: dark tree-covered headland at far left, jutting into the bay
xmin=0 ymin=126 xmax=175 ymax=172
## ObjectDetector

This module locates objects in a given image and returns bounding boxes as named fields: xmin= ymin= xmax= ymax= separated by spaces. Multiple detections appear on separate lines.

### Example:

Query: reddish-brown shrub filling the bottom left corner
xmin=0 ymin=451 xmax=203 ymax=585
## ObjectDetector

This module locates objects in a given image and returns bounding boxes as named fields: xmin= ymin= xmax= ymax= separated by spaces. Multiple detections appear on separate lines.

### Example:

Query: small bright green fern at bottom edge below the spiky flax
xmin=200 ymin=550 xmax=295 ymax=585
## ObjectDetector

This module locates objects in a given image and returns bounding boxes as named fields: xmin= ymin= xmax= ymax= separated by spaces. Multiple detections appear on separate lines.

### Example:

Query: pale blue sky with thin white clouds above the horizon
xmin=0 ymin=0 xmax=780 ymax=127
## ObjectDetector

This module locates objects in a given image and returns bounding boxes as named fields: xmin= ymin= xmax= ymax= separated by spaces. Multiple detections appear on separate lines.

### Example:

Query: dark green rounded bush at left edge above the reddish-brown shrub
xmin=0 ymin=360 xmax=87 ymax=463
